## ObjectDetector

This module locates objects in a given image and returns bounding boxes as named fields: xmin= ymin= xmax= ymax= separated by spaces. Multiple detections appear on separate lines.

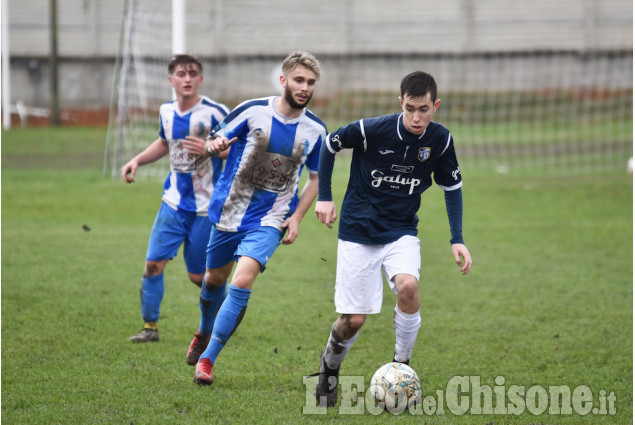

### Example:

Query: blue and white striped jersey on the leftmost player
xmin=159 ymin=96 xmax=229 ymax=215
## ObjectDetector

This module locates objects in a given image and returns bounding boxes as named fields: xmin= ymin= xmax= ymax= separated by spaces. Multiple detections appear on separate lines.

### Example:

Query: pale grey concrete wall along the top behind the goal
xmin=3 ymin=0 xmax=633 ymax=114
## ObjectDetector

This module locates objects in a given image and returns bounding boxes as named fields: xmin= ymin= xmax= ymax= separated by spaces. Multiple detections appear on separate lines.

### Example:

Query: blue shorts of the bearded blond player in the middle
xmin=207 ymin=226 xmax=282 ymax=272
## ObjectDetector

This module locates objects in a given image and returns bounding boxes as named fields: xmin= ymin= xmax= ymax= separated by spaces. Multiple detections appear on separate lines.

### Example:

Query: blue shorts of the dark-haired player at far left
xmin=146 ymin=202 xmax=212 ymax=274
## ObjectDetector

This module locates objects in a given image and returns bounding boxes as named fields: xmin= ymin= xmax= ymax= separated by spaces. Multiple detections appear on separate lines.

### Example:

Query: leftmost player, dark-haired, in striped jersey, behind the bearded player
xmin=121 ymin=55 xmax=229 ymax=342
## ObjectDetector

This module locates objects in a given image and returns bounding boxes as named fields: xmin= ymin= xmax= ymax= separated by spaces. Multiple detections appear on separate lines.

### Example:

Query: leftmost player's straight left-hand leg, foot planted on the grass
xmin=130 ymin=203 xmax=187 ymax=342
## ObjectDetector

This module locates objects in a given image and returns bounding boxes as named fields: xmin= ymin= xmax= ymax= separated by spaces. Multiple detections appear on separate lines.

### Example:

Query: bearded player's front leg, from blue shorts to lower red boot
xmin=194 ymin=226 xmax=282 ymax=385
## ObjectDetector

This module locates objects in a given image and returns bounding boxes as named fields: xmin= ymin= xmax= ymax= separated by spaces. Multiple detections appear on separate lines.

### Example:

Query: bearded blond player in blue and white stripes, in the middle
xmin=186 ymin=51 xmax=326 ymax=385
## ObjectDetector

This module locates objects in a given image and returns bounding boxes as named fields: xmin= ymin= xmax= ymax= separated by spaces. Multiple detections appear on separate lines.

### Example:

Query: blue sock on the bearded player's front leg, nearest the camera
xmin=201 ymin=284 xmax=251 ymax=364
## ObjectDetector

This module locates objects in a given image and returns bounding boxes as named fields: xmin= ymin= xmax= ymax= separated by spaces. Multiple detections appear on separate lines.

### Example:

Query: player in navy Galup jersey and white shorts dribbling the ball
xmin=315 ymin=71 xmax=472 ymax=406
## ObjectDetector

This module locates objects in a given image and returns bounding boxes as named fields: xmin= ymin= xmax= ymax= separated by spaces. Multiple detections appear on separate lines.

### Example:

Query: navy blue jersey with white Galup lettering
xmin=320 ymin=114 xmax=462 ymax=245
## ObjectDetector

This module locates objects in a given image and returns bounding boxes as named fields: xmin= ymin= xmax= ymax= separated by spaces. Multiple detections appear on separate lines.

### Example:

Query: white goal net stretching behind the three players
xmin=104 ymin=0 xmax=633 ymax=178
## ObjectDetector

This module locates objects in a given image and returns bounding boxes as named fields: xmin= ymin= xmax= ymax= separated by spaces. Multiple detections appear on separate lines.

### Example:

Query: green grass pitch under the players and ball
xmin=1 ymin=128 xmax=633 ymax=425
